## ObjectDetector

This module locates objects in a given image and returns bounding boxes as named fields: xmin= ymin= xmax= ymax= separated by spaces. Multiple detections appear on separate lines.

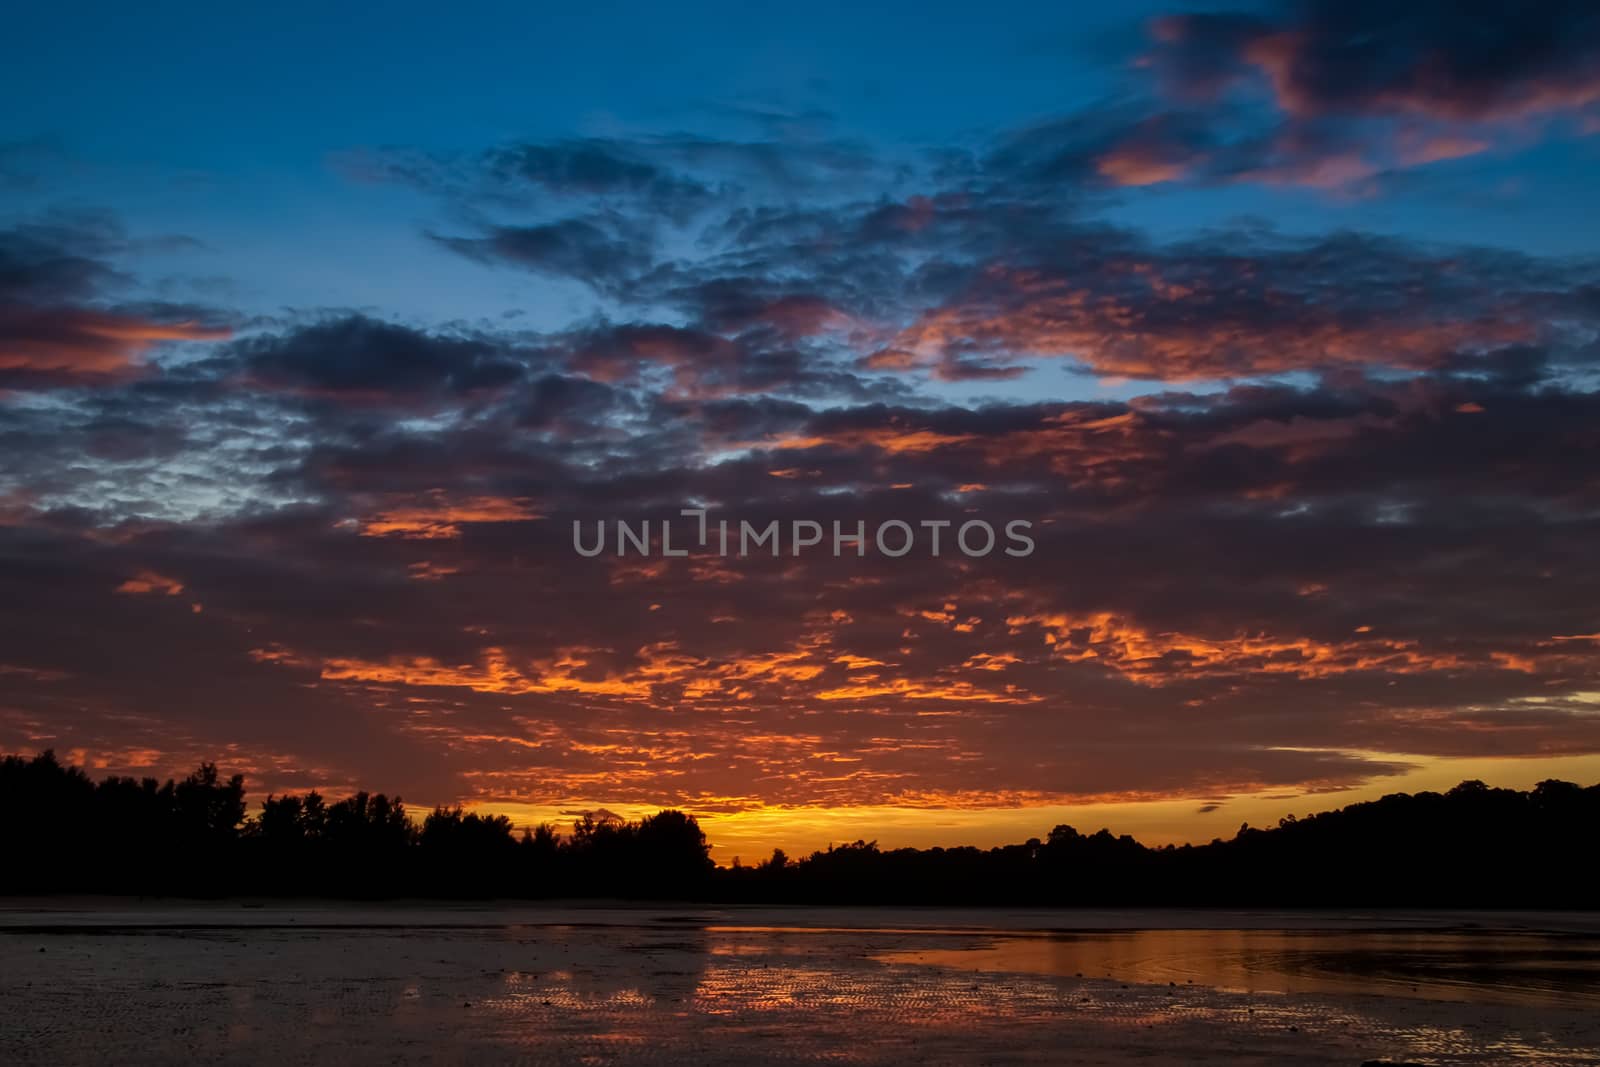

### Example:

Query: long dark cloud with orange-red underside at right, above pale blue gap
xmin=870 ymin=229 xmax=1594 ymax=381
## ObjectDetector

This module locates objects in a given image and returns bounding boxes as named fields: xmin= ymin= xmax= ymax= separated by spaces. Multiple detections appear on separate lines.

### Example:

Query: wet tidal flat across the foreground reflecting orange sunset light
xmin=0 ymin=901 xmax=1600 ymax=1067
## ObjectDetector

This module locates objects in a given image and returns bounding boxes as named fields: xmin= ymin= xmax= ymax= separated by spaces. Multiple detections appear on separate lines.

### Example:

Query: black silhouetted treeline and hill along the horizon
xmin=0 ymin=752 xmax=1600 ymax=909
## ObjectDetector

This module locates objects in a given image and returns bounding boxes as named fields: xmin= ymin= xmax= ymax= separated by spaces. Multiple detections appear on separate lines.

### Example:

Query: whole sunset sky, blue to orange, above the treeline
xmin=0 ymin=0 xmax=1600 ymax=862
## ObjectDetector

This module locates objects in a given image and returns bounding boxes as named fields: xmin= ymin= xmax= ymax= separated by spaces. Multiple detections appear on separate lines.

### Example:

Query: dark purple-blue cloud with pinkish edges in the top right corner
xmin=1068 ymin=0 xmax=1600 ymax=190
